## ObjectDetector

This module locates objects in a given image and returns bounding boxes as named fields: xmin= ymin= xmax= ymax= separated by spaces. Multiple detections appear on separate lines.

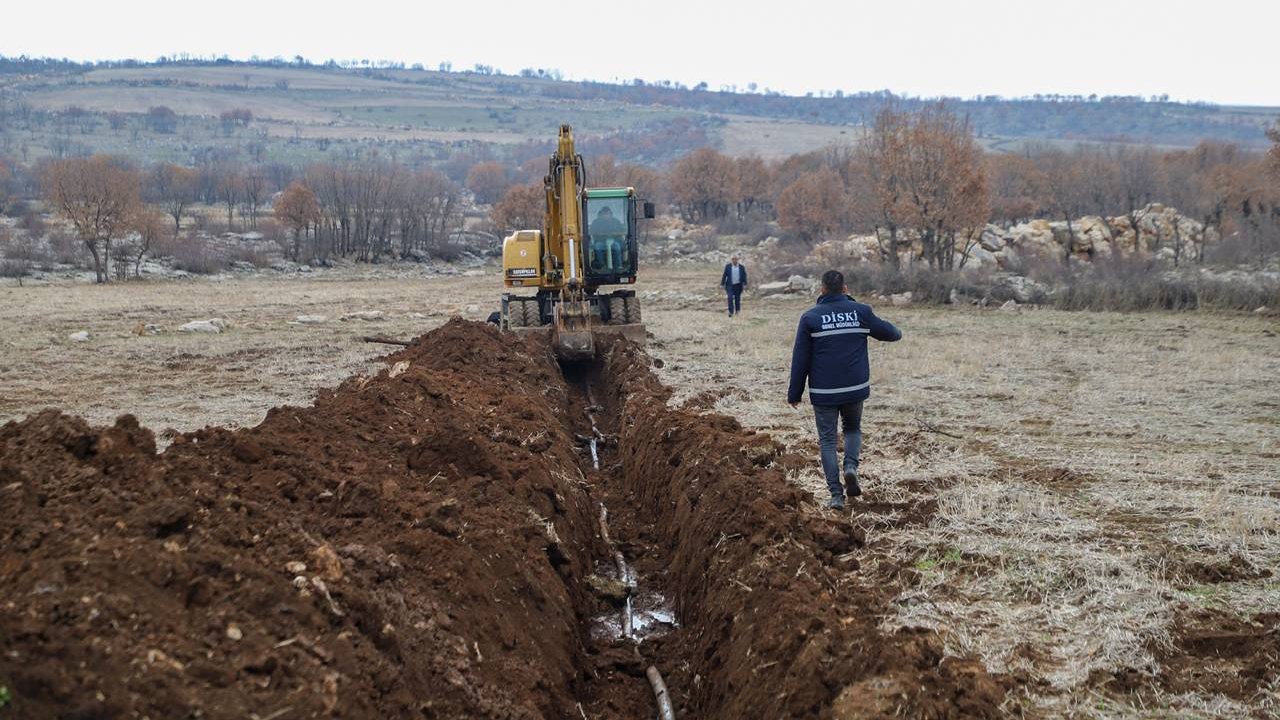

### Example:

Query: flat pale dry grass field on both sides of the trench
xmin=0 ymin=266 xmax=1280 ymax=717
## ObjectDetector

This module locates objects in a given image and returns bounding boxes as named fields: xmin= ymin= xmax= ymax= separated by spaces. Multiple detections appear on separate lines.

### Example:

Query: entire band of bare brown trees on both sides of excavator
xmin=0 ymin=105 xmax=1280 ymax=282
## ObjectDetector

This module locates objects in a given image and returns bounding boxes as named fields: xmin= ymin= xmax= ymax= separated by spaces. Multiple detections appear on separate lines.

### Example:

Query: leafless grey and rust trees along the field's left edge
xmin=11 ymin=155 xmax=468 ymax=282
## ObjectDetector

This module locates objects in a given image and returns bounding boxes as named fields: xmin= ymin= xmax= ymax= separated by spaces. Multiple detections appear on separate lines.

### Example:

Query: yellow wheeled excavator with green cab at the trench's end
xmin=499 ymin=126 xmax=654 ymax=360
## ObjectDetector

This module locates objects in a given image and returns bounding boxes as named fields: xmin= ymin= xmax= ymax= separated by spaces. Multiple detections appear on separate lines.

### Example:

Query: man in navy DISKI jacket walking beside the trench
xmin=787 ymin=270 xmax=902 ymax=510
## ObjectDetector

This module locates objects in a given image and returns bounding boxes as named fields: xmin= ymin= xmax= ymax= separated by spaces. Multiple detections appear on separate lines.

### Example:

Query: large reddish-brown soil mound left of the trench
xmin=0 ymin=323 xmax=603 ymax=719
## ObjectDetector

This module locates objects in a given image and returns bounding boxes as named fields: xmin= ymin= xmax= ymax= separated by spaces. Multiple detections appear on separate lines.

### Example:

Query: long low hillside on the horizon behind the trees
xmin=0 ymin=58 xmax=1280 ymax=164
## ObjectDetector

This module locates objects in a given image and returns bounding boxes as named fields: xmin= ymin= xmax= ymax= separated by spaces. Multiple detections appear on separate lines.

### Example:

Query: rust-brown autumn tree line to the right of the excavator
xmin=619 ymin=105 xmax=1280 ymax=269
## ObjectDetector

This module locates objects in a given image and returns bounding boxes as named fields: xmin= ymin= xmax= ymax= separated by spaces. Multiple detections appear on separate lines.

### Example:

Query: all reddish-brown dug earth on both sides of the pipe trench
xmin=0 ymin=320 xmax=1007 ymax=720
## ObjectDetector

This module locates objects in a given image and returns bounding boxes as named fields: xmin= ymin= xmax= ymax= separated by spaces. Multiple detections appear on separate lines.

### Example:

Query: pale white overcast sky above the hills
xmin=0 ymin=0 xmax=1280 ymax=105
